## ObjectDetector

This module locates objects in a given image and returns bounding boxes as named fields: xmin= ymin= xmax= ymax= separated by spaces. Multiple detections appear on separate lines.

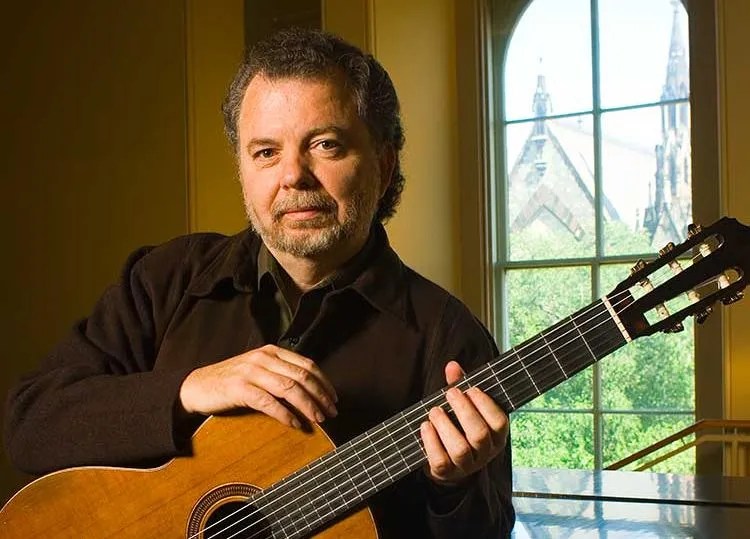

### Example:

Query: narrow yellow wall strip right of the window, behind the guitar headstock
xmin=718 ymin=0 xmax=750 ymax=419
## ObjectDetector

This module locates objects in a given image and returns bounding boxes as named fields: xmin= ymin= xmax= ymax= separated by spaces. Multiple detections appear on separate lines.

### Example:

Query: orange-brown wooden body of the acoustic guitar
xmin=0 ymin=414 xmax=377 ymax=539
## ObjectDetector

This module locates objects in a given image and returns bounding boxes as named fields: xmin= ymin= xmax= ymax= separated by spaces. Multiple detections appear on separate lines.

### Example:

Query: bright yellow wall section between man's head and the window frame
xmin=373 ymin=0 xmax=460 ymax=294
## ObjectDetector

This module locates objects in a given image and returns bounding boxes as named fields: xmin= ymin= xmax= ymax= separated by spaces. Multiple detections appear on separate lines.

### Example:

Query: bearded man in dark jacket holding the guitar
xmin=5 ymin=30 xmax=514 ymax=538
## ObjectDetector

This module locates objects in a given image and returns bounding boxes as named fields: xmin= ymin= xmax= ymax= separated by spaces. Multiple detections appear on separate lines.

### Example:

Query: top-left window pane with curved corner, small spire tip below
xmin=503 ymin=0 xmax=592 ymax=120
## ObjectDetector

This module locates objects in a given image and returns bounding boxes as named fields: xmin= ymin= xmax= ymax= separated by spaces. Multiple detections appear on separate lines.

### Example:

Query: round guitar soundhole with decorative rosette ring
xmin=187 ymin=483 xmax=273 ymax=539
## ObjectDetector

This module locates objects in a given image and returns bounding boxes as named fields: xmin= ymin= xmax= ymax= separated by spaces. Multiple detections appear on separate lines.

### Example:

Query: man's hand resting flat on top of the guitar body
xmin=180 ymin=345 xmax=337 ymax=428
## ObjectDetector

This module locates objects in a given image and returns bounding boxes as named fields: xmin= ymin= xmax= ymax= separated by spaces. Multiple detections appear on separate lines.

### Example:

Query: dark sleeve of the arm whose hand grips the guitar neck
xmin=422 ymin=298 xmax=515 ymax=539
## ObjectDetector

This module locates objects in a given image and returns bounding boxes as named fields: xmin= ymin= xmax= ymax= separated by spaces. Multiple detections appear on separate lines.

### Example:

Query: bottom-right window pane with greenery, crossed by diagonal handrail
xmin=604 ymin=414 xmax=695 ymax=474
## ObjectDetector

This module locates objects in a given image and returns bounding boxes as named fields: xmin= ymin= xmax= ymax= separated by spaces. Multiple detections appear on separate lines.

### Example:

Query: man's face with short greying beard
xmin=237 ymin=75 xmax=392 ymax=258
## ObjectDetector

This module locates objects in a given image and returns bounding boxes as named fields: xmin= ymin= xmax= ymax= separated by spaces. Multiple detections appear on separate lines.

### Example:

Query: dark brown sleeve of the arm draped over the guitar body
xmin=4 ymin=243 xmax=200 ymax=474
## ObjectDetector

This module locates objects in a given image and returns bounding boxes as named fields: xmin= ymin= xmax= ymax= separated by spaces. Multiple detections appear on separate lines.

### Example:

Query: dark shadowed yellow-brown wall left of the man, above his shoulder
xmin=0 ymin=0 xmax=192 ymax=501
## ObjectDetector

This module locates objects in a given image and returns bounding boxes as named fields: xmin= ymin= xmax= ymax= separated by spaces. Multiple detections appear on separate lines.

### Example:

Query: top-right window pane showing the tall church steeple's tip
xmin=599 ymin=0 xmax=689 ymax=108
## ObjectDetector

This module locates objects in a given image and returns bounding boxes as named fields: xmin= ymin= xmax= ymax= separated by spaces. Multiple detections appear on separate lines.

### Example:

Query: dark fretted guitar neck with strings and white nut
xmin=250 ymin=295 xmax=631 ymax=538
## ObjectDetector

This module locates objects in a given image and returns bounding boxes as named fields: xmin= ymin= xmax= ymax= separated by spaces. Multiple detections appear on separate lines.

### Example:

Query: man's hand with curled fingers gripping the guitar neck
xmin=420 ymin=361 xmax=508 ymax=485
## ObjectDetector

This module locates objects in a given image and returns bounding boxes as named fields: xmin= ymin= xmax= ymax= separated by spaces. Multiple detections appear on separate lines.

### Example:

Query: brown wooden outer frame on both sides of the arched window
xmin=456 ymin=0 xmax=724 ymax=473
